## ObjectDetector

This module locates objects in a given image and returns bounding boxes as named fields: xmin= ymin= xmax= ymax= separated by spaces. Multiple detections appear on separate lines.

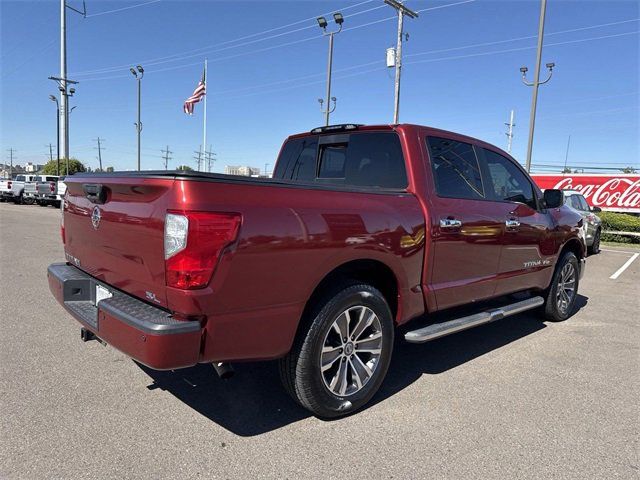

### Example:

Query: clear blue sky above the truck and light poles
xmin=0 ymin=0 xmax=640 ymax=172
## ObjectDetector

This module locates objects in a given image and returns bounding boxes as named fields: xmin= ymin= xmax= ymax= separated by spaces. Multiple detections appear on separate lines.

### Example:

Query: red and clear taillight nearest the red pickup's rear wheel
xmin=164 ymin=211 xmax=241 ymax=290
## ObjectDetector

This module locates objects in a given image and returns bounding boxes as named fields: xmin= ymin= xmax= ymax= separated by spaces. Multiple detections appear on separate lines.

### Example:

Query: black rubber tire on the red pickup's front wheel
xmin=543 ymin=252 xmax=580 ymax=322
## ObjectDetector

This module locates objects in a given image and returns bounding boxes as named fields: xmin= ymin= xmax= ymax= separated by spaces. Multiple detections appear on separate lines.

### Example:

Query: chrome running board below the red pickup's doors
xmin=404 ymin=297 xmax=544 ymax=343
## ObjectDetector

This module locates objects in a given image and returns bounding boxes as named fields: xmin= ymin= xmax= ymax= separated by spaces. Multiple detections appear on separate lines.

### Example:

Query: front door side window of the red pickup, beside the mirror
xmin=483 ymin=149 xmax=538 ymax=209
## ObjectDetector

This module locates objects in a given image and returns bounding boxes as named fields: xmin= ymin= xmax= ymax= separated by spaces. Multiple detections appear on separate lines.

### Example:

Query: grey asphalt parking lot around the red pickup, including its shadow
xmin=0 ymin=203 xmax=640 ymax=479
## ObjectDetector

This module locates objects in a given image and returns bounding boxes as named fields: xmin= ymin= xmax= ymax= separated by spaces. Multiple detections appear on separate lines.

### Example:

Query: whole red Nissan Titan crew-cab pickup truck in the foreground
xmin=48 ymin=125 xmax=585 ymax=417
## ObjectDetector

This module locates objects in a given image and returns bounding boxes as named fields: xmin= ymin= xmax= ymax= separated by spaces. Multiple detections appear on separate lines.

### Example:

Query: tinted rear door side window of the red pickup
xmin=427 ymin=137 xmax=484 ymax=199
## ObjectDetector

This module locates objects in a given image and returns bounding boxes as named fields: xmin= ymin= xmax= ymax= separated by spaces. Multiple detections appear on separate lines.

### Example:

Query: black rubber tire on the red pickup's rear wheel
xmin=280 ymin=282 xmax=394 ymax=418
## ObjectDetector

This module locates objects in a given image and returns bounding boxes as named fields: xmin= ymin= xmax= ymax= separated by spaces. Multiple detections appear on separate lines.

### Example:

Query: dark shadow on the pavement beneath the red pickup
xmin=138 ymin=295 xmax=588 ymax=436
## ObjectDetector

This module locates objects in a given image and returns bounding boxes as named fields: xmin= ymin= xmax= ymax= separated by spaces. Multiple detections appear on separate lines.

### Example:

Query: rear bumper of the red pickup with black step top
xmin=47 ymin=263 xmax=202 ymax=370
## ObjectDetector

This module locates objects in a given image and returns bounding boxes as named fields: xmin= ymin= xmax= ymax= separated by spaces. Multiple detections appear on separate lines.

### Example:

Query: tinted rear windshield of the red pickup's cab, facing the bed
xmin=273 ymin=132 xmax=408 ymax=189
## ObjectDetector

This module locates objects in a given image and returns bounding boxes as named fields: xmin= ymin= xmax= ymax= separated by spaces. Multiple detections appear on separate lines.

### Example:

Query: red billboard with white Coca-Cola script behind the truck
xmin=531 ymin=173 xmax=640 ymax=213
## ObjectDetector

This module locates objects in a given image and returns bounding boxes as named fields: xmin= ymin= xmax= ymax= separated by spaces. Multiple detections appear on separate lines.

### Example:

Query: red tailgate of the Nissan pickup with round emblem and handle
xmin=63 ymin=176 xmax=174 ymax=307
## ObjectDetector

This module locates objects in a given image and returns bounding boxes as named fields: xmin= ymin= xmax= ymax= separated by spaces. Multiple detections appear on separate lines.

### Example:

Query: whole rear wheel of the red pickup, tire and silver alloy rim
xmin=280 ymin=283 xmax=394 ymax=418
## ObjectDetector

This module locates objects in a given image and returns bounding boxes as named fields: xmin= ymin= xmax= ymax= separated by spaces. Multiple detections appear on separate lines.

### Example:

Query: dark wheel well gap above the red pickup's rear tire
xmin=303 ymin=260 xmax=398 ymax=319
